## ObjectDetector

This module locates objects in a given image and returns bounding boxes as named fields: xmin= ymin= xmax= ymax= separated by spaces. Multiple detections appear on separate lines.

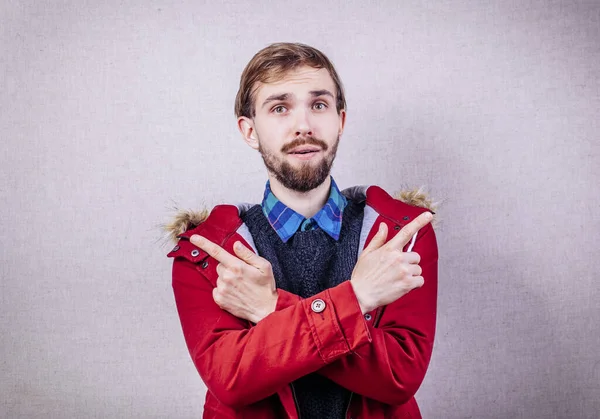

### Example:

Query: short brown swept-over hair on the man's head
xmin=235 ymin=42 xmax=346 ymax=118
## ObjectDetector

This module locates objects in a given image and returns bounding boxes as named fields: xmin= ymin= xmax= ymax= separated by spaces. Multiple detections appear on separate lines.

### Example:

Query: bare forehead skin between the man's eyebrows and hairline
xmin=255 ymin=66 xmax=336 ymax=104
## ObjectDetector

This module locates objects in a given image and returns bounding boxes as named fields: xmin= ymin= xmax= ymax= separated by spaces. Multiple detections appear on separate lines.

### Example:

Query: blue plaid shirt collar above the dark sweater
xmin=262 ymin=177 xmax=348 ymax=243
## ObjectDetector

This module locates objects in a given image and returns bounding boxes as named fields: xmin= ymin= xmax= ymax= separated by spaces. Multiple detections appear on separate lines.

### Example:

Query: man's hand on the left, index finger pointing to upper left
xmin=190 ymin=234 xmax=277 ymax=323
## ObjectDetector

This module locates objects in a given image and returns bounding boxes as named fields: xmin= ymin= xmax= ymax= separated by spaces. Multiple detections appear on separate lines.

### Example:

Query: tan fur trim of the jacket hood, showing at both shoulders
xmin=163 ymin=188 xmax=439 ymax=243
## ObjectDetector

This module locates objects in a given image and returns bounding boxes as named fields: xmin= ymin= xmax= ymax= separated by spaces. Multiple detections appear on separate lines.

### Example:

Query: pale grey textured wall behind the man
xmin=0 ymin=0 xmax=600 ymax=419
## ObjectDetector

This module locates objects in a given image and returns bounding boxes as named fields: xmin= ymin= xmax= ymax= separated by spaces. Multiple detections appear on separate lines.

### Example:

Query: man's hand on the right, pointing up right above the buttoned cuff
xmin=350 ymin=212 xmax=433 ymax=314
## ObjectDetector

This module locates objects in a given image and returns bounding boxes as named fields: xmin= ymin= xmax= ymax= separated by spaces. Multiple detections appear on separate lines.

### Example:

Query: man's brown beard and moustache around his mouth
xmin=258 ymin=136 xmax=340 ymax=192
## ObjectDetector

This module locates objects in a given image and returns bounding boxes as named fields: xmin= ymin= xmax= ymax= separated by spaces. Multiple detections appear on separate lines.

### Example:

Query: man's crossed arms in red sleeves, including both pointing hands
xmin=173 ymin=213 xmax=437 ymax=406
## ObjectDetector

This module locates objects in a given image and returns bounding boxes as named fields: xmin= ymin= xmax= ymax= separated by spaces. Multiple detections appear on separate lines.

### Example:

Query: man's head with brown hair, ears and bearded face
xmin=235 ymin=43 xmax=346 ymax=192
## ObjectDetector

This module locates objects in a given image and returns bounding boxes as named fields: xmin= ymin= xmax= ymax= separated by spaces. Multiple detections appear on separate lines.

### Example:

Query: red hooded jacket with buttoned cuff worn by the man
xmin=169 ymin=186 xmax=438 ymax=418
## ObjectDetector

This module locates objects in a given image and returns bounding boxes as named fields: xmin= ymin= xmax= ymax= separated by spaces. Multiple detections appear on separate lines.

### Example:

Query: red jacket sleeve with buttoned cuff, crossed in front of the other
xmin=173 ymin=257 xmax=371 ymax=407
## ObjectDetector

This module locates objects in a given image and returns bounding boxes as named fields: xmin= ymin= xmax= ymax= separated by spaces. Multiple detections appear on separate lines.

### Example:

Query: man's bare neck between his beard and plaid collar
xmin=269 ymin=173 xmax=331 ymax=218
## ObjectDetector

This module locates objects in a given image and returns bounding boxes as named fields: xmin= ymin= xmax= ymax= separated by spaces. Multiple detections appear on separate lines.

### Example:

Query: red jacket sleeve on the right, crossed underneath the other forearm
xmin=277 ymin=225 xmax=438 ymax=405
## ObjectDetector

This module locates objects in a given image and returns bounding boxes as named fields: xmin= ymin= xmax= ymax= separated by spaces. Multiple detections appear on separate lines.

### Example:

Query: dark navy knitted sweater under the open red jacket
xmin=242 ymin=199 xmax=364 ymax=419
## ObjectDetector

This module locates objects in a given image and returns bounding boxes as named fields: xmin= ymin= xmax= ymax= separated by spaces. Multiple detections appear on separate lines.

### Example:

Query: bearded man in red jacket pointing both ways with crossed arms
xmin=169 ymin=43 xmax=437 ymax=419
